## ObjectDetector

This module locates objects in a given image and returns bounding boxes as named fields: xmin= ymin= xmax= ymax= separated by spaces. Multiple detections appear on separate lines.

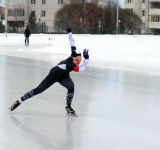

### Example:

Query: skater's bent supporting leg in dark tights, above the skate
xmin=59 ymin=76 xmax=74 ymax=106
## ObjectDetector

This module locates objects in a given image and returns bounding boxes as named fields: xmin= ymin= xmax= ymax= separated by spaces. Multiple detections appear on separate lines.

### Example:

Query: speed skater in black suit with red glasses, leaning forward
xmin=11 ymin=25 xmax=89 ymax=114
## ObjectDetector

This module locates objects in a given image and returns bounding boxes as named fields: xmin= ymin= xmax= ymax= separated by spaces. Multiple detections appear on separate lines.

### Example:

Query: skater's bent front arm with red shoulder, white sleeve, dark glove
xmin=73 ymin=49 xmax=89 ymax=72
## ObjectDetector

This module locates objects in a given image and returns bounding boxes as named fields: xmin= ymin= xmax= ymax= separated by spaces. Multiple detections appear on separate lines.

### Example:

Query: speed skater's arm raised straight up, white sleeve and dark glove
xmin=66 ymin=25 xmax=76 ymax=52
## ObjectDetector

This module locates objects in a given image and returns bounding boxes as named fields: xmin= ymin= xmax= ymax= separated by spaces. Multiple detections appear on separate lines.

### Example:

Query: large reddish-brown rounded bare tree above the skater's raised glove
xmin=54 ymin=3 xmax=104 ymax=33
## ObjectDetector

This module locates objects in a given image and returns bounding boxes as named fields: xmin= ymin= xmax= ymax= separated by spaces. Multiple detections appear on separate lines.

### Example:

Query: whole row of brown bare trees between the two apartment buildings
xmin=54 ymin=3 xmax=142 ymax=33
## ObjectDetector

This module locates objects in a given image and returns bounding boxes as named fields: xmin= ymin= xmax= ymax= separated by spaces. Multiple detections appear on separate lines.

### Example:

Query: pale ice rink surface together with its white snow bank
xmin=0 ymin=34 xmax=160 ymax=150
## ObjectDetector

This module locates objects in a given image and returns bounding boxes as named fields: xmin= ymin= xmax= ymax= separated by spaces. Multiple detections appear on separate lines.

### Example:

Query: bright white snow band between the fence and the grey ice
xmin=0 ymin=33 xmax=160 ymax=75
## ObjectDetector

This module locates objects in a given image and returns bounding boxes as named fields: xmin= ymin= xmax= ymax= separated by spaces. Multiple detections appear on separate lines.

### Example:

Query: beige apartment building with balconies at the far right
xmin=124 ymin=0 xmax=160 ymax=34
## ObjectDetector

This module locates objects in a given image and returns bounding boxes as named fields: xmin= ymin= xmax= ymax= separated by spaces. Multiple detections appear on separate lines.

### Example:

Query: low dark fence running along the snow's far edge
xmin=0 ymin=26 xmax=141 ymax=35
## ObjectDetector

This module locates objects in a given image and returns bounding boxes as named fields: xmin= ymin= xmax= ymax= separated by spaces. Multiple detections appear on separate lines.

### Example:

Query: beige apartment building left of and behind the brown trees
xmin=5 ymin=0 xmax=108 ymax=31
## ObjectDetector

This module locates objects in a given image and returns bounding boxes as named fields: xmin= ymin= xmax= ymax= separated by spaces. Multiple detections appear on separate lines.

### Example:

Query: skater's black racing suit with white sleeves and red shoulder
xmin=21 ymin=32 xmax=88 ymax=105
